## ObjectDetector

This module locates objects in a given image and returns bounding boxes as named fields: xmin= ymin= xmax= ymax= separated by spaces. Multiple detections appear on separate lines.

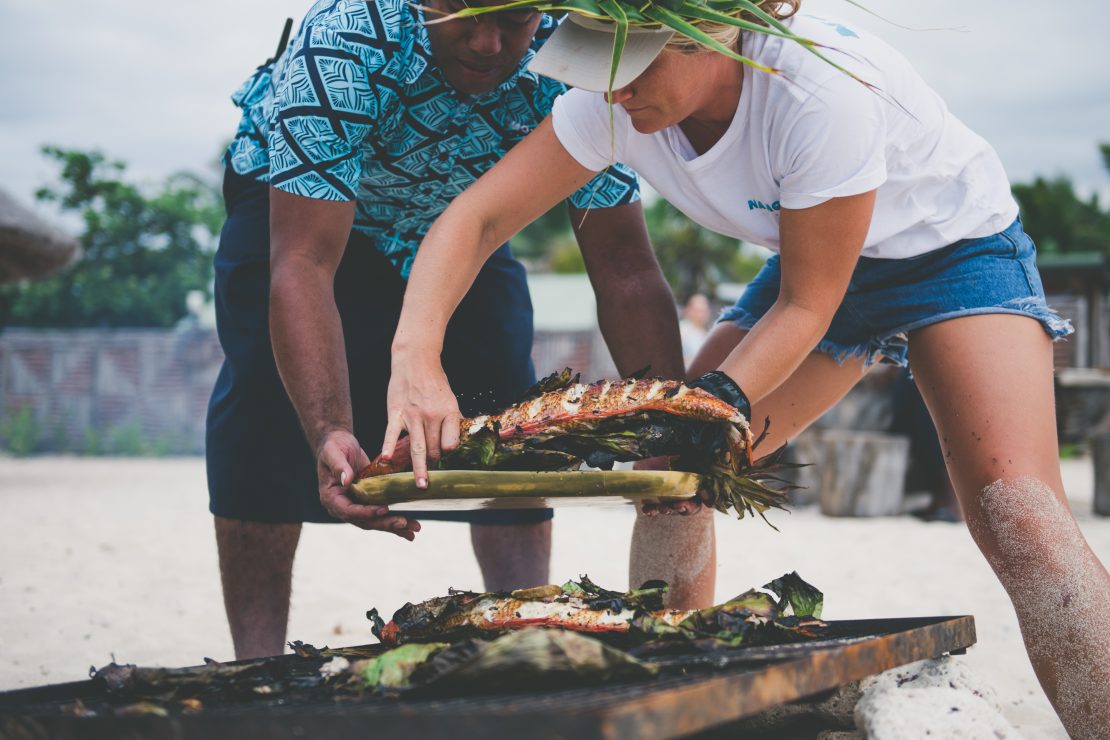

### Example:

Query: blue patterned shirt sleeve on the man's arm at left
xmin=269 ymin=16 xmax=395 ymax=201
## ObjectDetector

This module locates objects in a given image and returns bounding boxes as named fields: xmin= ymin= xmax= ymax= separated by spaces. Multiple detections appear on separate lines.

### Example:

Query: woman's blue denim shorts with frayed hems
xmin=719 ymin=219 xmax=1072 ymax=367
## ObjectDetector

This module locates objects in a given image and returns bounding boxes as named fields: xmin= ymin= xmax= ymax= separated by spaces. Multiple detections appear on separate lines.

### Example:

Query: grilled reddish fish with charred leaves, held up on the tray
xmin=359 ymin=368 xmax=794 ymax=518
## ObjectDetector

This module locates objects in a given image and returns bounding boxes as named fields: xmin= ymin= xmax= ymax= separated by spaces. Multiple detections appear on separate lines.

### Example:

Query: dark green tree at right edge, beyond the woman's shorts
xmin=1013 ymin=144 xmax=1110 ymax=254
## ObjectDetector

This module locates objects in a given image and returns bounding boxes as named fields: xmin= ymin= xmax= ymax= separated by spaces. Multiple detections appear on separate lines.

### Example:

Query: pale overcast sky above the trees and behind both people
xmin=0 ymin=0 xmax=1110 ymax=208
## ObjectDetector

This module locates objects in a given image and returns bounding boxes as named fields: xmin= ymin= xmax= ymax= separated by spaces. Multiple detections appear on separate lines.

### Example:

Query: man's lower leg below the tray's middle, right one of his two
xmin=471 ymin=519 xmax=552 ymax=591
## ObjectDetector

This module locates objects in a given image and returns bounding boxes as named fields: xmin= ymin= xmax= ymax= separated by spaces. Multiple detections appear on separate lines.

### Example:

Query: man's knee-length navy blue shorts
xmin=205 ymin=171 xmax=552 ymax=525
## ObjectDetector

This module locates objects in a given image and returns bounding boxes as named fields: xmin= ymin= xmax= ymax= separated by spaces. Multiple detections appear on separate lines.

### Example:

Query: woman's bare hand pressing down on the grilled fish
xmin=382 ymin=349 xmax=462 ymax=488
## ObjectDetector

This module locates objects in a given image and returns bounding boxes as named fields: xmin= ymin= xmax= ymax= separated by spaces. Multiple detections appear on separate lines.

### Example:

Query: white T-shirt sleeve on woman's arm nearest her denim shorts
xmin=775 ymin=72 xmax=892 ymax=209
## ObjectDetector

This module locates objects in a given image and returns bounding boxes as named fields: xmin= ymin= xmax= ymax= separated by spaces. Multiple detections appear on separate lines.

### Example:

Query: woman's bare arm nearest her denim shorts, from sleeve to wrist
xmin=720 ymin=191 xmax=875 ymax=403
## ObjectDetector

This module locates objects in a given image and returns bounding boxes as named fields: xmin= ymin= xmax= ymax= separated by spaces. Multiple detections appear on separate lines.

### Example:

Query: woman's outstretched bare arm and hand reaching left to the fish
xmin=382 ymin=118 xmax=595 ymax=488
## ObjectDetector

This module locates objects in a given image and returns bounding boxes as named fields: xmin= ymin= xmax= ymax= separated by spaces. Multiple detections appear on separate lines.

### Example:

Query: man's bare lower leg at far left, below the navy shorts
xmin=215 ymin=517 xmax=301 ymax=660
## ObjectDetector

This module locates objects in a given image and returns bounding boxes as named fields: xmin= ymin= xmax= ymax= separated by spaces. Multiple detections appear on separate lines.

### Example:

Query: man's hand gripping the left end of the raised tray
xmin=316 ymin=430 xmax=420 ymax=541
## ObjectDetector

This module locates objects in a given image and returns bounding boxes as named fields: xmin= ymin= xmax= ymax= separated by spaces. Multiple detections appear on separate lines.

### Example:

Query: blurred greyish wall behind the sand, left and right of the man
xmin=0 ymin=328 xmax=613 ymax=455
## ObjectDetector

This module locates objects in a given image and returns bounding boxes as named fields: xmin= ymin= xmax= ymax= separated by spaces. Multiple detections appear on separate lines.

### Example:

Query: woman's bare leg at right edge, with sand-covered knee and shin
xmin=910 ymin=314 xmax=1110 ymax=738
